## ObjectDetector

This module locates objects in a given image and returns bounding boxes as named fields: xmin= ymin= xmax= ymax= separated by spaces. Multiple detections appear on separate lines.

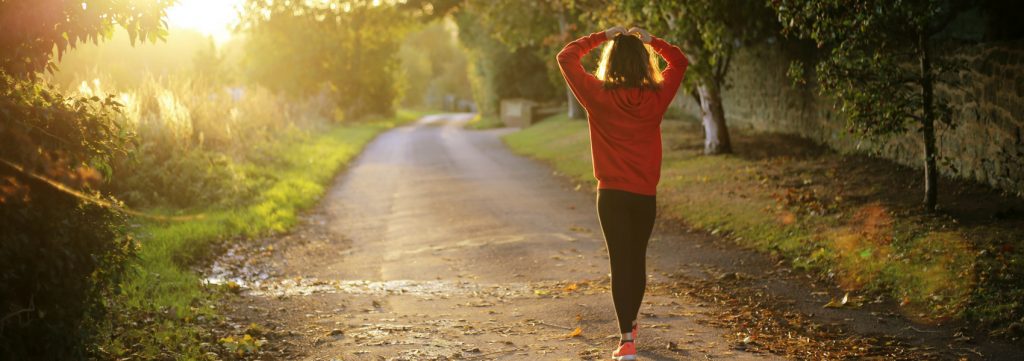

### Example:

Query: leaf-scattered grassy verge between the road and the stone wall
xmin=505 ymin=117 xmax=1024 ymax=337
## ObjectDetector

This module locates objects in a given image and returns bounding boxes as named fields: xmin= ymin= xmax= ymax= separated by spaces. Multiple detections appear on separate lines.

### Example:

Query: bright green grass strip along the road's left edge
xmin=99 ymin=111 xmax=421 ymax=360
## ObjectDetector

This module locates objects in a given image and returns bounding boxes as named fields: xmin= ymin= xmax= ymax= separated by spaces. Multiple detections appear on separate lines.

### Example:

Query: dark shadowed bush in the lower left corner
xmin=0 ymin=188 xmax=136 ymax=360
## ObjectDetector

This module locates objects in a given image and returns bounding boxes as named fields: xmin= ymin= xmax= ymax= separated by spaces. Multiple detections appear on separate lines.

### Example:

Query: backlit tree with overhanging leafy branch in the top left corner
xmin=0 ymin=0 xmax=173 ymax=208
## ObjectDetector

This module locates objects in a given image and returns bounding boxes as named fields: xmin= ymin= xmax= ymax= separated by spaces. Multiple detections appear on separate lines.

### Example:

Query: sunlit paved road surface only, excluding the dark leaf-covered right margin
xmin=222 ymin=115 xmax=774 ymax=360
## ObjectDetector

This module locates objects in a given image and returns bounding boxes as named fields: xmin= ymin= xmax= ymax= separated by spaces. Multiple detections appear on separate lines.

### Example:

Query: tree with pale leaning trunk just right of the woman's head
xmin=583 ymin=0 xmax=776 ymax=154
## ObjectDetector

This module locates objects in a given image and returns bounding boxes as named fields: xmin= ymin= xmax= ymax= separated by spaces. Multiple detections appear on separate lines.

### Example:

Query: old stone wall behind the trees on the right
xmin=712 ymin=41 xmax=1024 ymax=195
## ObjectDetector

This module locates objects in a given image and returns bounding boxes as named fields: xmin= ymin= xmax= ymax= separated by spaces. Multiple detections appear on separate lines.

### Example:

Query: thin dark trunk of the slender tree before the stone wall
xmin=918 ymin=34 xmax=939 ymax=212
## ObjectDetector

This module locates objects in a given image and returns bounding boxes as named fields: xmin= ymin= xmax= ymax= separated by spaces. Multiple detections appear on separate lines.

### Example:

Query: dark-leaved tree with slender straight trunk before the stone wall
xmin=769 ymin=0 xmax=962 ymax=211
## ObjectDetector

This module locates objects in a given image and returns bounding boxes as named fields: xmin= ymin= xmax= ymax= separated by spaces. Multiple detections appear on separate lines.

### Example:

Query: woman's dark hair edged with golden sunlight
xmin=597 ymin=34 xmax=662 ymax=89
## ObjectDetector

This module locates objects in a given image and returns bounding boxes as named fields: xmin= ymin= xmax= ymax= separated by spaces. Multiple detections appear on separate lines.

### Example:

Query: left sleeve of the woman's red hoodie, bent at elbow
xmin=558 ymin=32 xmax=608 ymax=107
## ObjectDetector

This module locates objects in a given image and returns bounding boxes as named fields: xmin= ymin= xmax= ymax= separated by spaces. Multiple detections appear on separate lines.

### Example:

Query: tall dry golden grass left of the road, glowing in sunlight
xmin=74 ymin=76 xmax=334 ymax=209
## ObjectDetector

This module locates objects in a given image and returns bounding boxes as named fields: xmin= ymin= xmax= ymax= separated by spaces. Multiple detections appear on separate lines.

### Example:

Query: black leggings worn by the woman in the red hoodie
xmin=597 ymin=189 xmax=656 ymax=333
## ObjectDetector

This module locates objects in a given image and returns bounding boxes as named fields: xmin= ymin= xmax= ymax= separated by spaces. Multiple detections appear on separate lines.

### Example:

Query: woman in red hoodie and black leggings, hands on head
xmin=558 ymin=27 xmax=688 ymax=360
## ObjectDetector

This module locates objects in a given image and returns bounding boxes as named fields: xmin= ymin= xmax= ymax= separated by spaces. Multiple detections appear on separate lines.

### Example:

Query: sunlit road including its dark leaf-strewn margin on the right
xmin=213 ymin=115 xmax=1021 ymax=360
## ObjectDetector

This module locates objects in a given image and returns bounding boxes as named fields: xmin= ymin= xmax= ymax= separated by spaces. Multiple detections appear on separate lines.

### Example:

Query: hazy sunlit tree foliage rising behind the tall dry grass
xmin=243 ymin=0 xmax=410 ymax=119
